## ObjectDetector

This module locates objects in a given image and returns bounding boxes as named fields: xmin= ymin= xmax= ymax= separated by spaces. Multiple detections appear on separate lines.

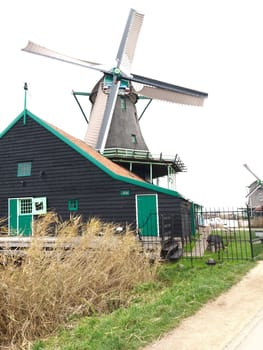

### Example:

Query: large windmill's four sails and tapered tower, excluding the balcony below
xmin=22 ymin=9 xmax=208 ymax=153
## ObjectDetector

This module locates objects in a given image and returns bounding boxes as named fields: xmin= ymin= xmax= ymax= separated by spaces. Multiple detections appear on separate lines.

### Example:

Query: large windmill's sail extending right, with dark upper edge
xmin=129 ymin=74 xmax=208 ymax=106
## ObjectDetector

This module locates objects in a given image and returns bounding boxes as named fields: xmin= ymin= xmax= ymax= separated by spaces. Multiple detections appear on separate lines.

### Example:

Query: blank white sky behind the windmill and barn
xmin=0 ymin=0 xmax=263 ymax=208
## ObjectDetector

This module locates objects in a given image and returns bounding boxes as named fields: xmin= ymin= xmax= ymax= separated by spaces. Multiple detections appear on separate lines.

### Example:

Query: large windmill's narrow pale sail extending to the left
xmin=22 ymin=41 xmax=106 ymax=73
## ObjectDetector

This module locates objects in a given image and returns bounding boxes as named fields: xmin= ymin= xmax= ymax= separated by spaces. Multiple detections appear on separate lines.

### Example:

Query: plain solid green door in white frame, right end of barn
xmin=136 ymin=194 xmax=159 ymax=236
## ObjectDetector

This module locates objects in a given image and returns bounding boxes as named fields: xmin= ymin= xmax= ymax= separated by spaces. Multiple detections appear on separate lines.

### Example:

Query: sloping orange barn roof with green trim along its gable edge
xmin=0 ymin=110 xmax=185 ymax=199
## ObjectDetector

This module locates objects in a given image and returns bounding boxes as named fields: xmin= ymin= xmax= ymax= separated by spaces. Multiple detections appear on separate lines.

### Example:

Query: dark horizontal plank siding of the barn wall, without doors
xmin=0 ymin=118 xmax=190 ymax=234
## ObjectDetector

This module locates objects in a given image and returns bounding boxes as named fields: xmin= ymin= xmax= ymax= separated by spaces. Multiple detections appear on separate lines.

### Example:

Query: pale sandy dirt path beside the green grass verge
xmin=143 ymin=261 xmax=263 ymax=350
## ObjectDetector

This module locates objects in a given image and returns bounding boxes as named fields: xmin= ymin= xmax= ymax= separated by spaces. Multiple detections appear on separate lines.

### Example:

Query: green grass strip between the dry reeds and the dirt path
xmin=33 ymin=260 xmax=255 ymax=350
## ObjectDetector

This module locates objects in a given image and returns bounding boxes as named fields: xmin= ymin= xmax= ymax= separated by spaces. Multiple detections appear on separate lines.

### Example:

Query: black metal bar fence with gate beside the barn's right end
xmin=140 ymin=207 xmax=263 ymax=264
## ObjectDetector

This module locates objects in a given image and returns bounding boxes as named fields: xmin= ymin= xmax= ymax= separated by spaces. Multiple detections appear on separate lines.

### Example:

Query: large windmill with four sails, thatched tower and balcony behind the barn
xmin=23 ymin=9 xmax=208 ymax=187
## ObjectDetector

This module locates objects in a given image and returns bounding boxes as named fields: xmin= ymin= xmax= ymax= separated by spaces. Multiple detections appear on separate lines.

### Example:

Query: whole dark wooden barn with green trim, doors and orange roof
xmin=0 ymin=109 xmax=192 ymax=241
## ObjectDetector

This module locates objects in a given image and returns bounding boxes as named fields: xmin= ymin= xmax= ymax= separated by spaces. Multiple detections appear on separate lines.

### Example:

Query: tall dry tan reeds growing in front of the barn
xmin=0 ymin=213 xmax=159 ymax=349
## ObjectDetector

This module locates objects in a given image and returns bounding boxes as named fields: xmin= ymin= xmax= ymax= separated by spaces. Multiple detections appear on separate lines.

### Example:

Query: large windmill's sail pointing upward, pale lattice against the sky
xmin=116 ymin=9 xmax=144 ymax=72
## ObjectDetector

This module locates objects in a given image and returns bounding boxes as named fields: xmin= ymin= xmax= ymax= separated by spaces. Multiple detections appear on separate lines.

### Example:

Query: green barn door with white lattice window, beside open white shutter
xmin=8 ymin=198 xmax=33 ymax=236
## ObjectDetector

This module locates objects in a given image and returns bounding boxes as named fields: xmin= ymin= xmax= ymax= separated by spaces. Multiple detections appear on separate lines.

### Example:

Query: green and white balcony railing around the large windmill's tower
xmin=103 ymin=148 xmax=182 ymax=162
